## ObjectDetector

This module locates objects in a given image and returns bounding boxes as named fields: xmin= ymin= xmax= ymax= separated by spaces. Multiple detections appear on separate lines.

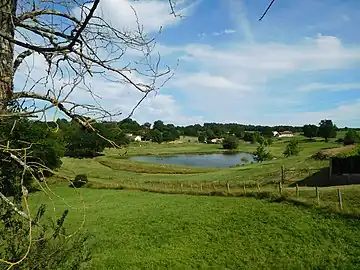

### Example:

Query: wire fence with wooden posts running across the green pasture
xmin=89 ymin=167 xmax=360 ymax=215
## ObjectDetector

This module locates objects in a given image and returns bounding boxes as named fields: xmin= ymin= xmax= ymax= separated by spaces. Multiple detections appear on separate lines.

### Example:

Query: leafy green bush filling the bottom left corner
xmin=0 ymin=202 xmax=91 ymax=269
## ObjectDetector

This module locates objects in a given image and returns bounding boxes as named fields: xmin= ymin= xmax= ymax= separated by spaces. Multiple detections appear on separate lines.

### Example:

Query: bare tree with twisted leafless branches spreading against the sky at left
xmin=0 ymin=0 xmax=177 ymax=267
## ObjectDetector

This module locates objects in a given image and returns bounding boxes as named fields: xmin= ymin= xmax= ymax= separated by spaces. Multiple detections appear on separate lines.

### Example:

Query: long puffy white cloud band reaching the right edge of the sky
xmin=182 ymin=35 xmax=360 ymax=77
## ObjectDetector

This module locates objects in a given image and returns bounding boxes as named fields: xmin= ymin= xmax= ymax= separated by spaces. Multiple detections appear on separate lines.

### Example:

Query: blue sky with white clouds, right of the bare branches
xmin=17 ymin=0 xmax=360 ymax=127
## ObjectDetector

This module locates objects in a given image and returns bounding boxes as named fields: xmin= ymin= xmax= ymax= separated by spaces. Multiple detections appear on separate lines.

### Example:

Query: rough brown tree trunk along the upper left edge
xmin=0 ymin=0 xmax=16 ymax=115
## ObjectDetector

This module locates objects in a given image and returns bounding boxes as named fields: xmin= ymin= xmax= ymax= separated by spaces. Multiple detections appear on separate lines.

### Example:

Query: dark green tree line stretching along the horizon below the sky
xmin=0 ymin=118 xmax=359 ymax=173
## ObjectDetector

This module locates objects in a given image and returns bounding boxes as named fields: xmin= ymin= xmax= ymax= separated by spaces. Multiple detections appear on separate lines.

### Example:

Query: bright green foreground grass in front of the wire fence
xmin=30 ymin=186 xmax=360 ymax=269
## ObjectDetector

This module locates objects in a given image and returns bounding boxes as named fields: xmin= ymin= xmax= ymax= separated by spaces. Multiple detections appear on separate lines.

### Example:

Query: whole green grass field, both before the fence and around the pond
xmin=31 ymin=137 xmax=360 ymax=269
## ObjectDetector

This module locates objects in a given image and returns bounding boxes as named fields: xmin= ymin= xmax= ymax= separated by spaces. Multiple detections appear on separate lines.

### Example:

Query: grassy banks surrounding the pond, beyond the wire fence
xmin=54 ymin=140 xmax=338 ymax=187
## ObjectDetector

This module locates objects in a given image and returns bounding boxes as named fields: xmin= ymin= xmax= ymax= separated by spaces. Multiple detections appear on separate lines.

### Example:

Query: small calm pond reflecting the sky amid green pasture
xmin=130 ymin=153 xmax=254 ymax=168
